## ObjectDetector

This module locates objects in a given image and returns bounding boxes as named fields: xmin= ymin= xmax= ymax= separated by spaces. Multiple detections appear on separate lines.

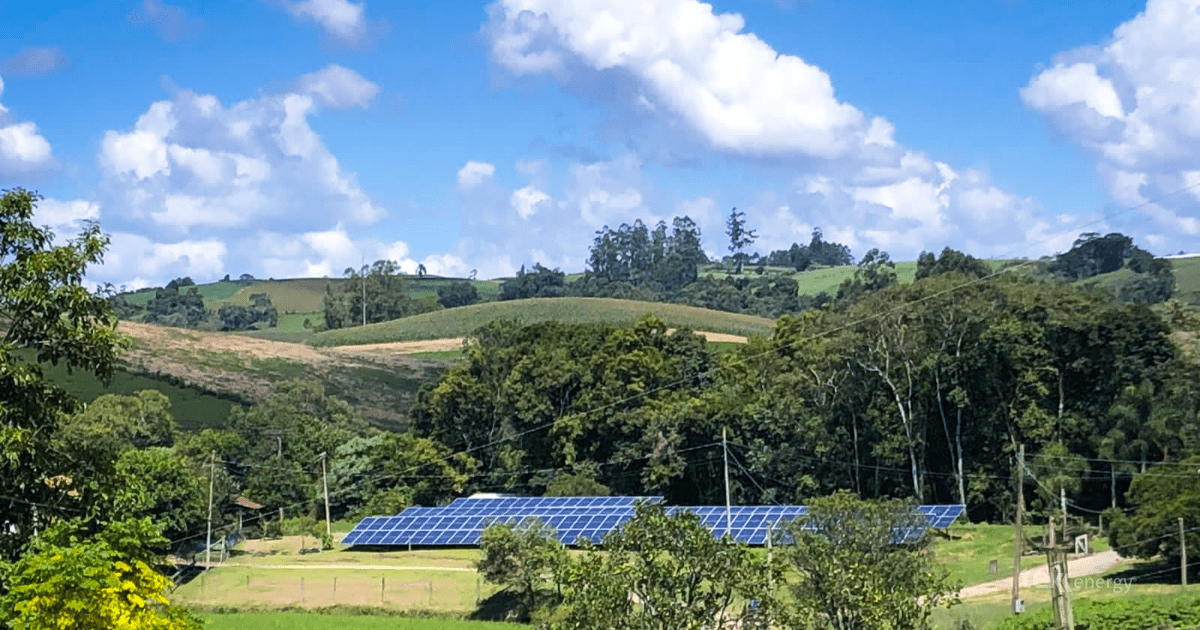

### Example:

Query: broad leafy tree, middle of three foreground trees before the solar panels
xmin=550 ymin=504 xmax=782 ymax=630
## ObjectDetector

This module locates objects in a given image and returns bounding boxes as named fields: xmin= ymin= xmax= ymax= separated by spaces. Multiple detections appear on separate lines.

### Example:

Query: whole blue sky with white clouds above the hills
xmin=0 ymin=0 xmax=1200 ymax=287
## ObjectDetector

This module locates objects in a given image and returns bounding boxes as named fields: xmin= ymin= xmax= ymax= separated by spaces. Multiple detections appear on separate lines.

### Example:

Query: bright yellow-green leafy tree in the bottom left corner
xmin=0 ymin=521 xmax=204 ymax=630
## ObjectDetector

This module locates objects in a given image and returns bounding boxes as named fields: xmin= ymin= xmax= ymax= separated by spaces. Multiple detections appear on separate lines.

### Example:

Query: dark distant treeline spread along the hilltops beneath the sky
xmin=114 ymin=211 xmax=1175 ymax=330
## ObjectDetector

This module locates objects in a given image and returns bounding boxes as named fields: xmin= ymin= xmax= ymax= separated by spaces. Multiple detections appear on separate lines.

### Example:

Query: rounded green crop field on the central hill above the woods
xmin=311 ymin=298 xmax=775 ymax=346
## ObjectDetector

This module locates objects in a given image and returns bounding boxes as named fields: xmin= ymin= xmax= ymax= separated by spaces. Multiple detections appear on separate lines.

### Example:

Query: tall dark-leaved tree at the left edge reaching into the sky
xmin=0 ymin=188 xmax=127 ymax=559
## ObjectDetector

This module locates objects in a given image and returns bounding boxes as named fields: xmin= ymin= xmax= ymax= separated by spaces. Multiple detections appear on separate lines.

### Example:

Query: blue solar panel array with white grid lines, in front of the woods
xmin=342 ymin=497 xmax=964 ymax=546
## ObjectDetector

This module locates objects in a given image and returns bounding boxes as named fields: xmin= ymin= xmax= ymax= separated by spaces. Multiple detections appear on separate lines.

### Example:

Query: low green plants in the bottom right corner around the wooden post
xmin=998 ymin=596 xmax=1200 ymax=630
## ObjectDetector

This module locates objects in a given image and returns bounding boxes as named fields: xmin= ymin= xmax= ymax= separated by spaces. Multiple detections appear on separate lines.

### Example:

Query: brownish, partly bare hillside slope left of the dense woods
xmin=120 ymin=322 xmax=446 ymax=430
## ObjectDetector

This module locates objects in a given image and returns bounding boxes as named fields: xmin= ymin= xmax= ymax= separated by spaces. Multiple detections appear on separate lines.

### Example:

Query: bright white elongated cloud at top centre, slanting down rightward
xmin=485 ymin=0 xmax=873 ymax=157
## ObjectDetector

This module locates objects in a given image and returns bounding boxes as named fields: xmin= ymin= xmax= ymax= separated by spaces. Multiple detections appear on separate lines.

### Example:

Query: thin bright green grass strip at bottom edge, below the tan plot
xmin=200 ymin=612 xmax=529 ymax=630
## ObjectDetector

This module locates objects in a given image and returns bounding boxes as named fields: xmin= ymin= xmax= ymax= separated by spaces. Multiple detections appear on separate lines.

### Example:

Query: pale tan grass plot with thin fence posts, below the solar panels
xmin=172 ymin=566 xmax=498 ymax=612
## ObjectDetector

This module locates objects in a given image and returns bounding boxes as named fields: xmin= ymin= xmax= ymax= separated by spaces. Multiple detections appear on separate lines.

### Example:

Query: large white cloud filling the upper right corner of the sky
xmin=1021 ymin=0 xmax=1200 ymax=251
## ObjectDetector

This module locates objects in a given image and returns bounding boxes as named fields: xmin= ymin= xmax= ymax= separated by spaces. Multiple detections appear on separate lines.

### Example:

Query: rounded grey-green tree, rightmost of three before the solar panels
xmin=776 ymin=492 xmax=958 ymax=630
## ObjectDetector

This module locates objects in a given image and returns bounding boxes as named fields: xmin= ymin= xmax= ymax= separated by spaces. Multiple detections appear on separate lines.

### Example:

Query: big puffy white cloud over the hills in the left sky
xmin=70 ymin=66 xmax=416 ymax=283
